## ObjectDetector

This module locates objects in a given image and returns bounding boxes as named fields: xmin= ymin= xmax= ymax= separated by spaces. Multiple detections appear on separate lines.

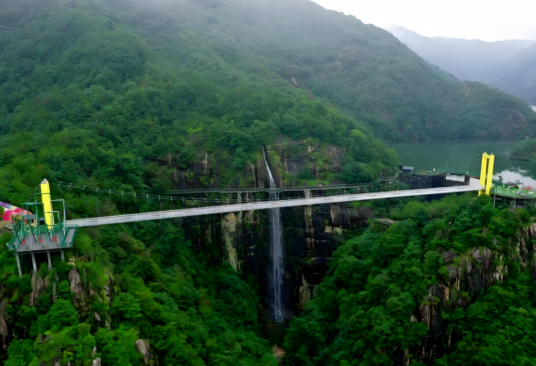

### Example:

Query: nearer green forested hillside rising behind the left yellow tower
xmin=0 ymin=0 xmax=397 ymax=202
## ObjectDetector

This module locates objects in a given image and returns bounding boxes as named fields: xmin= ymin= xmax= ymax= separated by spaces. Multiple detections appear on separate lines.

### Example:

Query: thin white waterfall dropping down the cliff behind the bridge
xmin=263 ymin=149 xmax=284 ymax=322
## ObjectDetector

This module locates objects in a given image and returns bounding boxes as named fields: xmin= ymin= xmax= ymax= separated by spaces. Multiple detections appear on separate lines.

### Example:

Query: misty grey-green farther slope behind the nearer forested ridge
xmin=132 ymin=0 xmax=534 ymax=140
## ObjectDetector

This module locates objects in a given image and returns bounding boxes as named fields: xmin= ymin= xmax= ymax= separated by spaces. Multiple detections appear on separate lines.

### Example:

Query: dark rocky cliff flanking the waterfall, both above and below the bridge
xmin=174 ymin=141 xmax=373 ymax=318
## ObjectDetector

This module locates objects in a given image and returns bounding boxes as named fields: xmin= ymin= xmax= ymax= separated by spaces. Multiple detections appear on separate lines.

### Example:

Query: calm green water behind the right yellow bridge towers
xmin=391 ymin=140 xmax=536 ymax=187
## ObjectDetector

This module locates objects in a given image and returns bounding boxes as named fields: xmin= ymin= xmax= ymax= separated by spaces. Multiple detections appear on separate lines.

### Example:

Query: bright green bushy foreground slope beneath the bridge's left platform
xmin=0 ymin=222 xmax=276 ymax=366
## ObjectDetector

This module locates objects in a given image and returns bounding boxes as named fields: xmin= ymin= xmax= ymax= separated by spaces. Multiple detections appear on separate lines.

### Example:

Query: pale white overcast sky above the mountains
xmin=313 ymin=0 xmax=536 ymax=41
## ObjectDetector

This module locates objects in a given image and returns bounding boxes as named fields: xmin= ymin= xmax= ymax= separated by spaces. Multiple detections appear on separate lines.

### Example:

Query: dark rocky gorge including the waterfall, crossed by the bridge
xmin=175 ymin=144 xmax=374 ymax=321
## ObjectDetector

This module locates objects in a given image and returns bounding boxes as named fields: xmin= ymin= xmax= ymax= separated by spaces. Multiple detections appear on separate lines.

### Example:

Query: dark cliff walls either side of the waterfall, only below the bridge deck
xmin=183 ymin=197 xmax=373 ymax=318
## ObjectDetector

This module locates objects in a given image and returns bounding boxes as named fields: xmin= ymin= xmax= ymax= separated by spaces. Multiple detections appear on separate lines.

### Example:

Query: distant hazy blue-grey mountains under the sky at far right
xmin=389 ymin=26 xmax=536 ymax=105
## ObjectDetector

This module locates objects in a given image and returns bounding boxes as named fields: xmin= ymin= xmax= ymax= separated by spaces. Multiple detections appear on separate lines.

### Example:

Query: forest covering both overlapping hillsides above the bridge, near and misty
xmin=0 ymin=0 xmax=532 ymax=202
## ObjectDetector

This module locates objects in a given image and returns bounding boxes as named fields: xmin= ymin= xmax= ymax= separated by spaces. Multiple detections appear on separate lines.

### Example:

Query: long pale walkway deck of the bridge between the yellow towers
xmin=67 ymin=179 xmax=485 ymax=227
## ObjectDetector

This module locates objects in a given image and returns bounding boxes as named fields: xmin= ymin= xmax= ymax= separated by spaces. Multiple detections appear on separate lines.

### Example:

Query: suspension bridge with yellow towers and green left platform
xmin=7 ymin=153 xmax=495 ymax=275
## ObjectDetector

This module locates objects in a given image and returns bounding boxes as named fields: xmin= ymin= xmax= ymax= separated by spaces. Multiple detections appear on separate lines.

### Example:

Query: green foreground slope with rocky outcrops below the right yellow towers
xmin=285 ymin=195 xmax=536 ymax=365
